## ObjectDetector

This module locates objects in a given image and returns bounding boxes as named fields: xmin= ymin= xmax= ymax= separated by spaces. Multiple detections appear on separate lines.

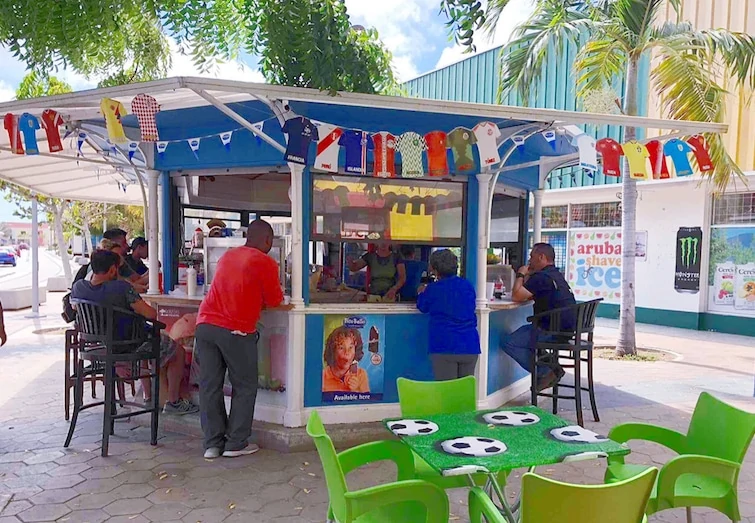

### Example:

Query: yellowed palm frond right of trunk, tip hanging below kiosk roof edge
xmin=650 ymin=34 xmax=743 ymax=190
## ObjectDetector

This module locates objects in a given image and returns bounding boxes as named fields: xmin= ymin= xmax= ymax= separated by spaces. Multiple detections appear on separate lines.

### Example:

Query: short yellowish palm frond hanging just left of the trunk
xmin=573 ymin=34 xmax=629 ymax=98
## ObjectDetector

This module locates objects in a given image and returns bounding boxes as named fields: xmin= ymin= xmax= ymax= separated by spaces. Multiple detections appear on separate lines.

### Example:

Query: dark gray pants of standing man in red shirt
xmin=194 ymin=323 xmax=259 ymax=450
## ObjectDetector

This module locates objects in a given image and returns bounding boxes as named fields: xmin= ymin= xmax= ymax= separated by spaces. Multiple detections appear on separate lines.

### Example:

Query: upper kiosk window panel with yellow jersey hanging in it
xmin=312 ymin=175 xmax=465 ymax=246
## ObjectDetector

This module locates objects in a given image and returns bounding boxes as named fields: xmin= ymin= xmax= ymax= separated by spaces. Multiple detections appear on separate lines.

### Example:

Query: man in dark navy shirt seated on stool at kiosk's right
xmin=503 ymin=243 xmax=576 ymax=390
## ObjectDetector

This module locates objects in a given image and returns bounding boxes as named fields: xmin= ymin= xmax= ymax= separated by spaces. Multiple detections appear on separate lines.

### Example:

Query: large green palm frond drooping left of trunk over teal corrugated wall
xmin=498 ymin=0 xmax=596 ymax=105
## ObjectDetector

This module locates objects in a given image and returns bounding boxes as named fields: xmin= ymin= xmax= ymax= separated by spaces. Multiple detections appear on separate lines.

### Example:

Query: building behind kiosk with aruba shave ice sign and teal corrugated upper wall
xmin=405 ymin=0 xmax=755 ymax=336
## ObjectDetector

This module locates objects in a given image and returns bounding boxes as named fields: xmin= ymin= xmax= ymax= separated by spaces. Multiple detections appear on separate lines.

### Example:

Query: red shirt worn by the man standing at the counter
xmin=197 ymin=246 xmax=283 ymax=333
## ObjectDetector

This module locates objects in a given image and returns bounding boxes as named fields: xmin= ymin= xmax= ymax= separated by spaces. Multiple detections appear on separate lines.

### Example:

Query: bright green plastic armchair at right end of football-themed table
xmin=605 ymin=392 xmax=755 ymax=522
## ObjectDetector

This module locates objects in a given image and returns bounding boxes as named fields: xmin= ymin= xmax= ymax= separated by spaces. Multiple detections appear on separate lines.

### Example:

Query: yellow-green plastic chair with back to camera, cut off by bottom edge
xmin=469 ymin=468 xmax=658 ymax=523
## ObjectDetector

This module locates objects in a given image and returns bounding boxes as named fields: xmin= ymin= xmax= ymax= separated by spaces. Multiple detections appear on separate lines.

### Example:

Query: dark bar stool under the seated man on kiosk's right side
xmin=527 ymin=298 xmax=603 ymax=426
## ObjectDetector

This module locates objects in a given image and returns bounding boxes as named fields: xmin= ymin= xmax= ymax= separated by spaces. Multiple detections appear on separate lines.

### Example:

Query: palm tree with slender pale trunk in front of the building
xmin=441 ymin=0 xmax=755 ymax=354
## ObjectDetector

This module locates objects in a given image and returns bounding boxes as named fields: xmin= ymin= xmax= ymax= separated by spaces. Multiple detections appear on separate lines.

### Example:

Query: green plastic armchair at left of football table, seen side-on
xmin=307 ymin=411 xmax=448 ymax=523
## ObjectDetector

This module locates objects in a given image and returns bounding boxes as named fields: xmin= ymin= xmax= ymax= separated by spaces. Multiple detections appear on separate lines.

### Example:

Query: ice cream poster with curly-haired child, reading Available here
xmin=322 ymin=314 xmax=385 ymax=403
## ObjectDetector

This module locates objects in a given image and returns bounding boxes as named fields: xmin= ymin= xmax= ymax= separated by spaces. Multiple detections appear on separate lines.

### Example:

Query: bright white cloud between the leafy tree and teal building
xmin=346 ymin=0 xmax=444 ymax=81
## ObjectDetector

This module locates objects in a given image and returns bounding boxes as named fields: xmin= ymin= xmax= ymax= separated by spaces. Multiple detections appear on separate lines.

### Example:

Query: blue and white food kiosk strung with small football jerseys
xmin=3 ymin=77 xmax=725 ymax=427
